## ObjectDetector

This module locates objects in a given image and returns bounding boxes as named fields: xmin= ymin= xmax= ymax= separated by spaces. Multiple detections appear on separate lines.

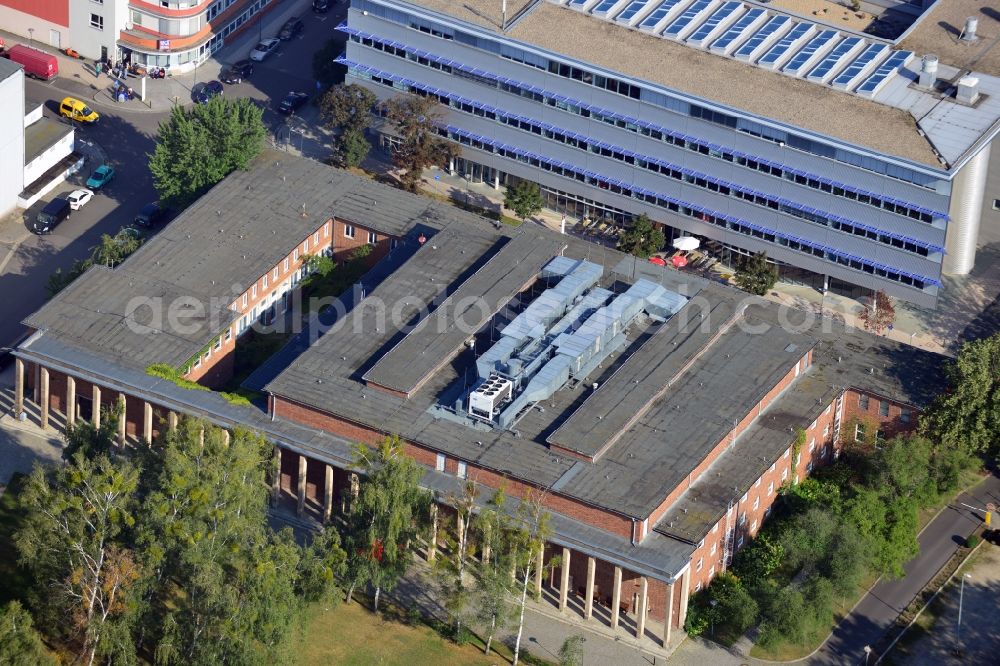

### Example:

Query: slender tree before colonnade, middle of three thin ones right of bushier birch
xmin=472 ymin=488 xmax=517 ymax=654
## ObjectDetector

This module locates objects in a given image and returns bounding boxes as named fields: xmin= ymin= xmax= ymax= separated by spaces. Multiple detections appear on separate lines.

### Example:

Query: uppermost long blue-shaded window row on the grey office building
xmin=351 ymin=35 xmax=945 ymax=224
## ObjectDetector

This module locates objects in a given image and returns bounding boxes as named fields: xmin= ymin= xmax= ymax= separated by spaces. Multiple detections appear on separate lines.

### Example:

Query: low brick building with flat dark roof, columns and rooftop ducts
xmin=16 ymin=157 xmax=940 ymax=643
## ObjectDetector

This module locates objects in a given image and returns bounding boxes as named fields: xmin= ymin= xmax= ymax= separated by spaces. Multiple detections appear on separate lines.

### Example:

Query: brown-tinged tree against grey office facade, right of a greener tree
xmin=385 ymin=95 xmax=459 ymax=192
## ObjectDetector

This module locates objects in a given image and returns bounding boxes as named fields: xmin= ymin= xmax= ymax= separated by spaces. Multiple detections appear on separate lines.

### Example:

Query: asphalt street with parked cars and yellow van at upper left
xmin=0 ymin=4 xmax=347 ymax=348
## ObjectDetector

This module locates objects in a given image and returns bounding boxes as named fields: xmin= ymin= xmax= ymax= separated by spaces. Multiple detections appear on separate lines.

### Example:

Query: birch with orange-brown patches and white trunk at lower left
xmin=15 ymin=453 xmax=142 ymax=664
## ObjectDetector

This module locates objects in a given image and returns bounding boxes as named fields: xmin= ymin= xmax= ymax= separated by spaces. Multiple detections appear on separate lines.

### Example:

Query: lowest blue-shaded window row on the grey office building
xmin=439 ymin=120 xmax=937 ymax=289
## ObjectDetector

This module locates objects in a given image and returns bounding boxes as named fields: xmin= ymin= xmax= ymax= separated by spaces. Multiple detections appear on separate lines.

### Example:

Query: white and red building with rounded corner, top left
xmin=0 ymin=0 xmax=275 ymax=72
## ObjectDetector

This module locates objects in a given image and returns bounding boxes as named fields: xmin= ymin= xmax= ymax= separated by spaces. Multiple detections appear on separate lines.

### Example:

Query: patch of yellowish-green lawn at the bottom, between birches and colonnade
xmin=290 ymin=603 xmax=510 ymax=666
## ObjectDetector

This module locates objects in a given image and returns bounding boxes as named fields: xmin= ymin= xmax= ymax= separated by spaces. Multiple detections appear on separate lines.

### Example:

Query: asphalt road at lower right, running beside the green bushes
xmin=808 ymin=475 xmax=1000 ymax=666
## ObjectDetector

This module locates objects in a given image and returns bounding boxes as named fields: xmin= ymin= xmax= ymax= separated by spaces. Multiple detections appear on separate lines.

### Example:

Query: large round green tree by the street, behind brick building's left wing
xmin=149 ymin=96 xmax=267 ymax=206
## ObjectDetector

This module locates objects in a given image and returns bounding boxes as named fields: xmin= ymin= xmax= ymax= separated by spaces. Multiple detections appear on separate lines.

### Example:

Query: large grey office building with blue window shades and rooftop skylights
xmin=339 ymin=0 xmax=1000 ymax=306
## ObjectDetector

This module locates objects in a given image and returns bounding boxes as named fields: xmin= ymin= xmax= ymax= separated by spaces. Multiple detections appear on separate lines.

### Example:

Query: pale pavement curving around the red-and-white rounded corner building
xmin=0 ymin=0 xmax=310 ymax=113
